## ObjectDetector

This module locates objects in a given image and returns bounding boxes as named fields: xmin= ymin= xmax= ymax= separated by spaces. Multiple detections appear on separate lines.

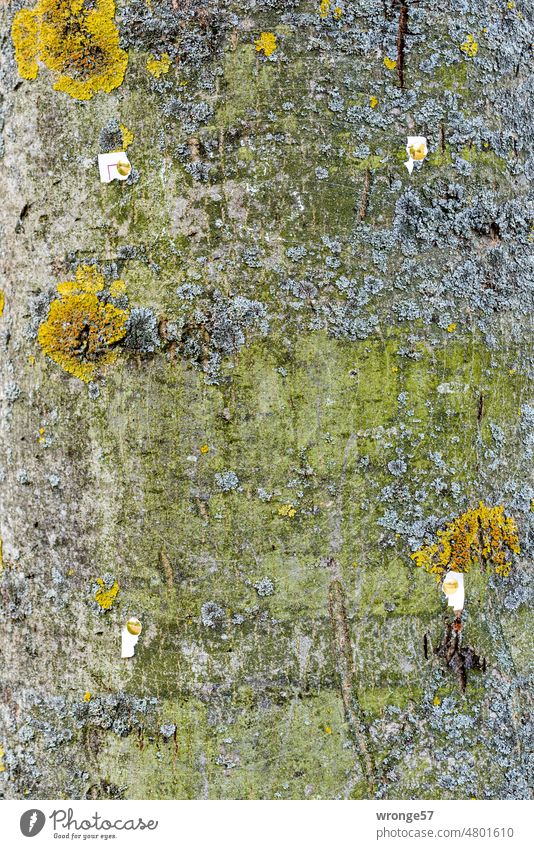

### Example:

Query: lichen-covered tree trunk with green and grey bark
xmin=0 ymin=0 xmax=534 ymax=799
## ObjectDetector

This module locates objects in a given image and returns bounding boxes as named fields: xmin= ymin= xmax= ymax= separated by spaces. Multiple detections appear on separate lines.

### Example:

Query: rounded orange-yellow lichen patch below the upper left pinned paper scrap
xmin=37 ymin=266 xmax=128 ymax=382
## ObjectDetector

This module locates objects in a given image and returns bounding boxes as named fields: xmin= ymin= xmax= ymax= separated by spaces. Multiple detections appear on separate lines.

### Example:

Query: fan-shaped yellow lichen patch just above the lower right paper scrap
xmin=412 ymin=501 xmax=520 ymax=581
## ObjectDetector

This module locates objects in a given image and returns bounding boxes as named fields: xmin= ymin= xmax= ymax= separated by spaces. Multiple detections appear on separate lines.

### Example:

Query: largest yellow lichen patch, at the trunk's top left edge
xmin=11 ymin=0 xmax=128 ymax=100
